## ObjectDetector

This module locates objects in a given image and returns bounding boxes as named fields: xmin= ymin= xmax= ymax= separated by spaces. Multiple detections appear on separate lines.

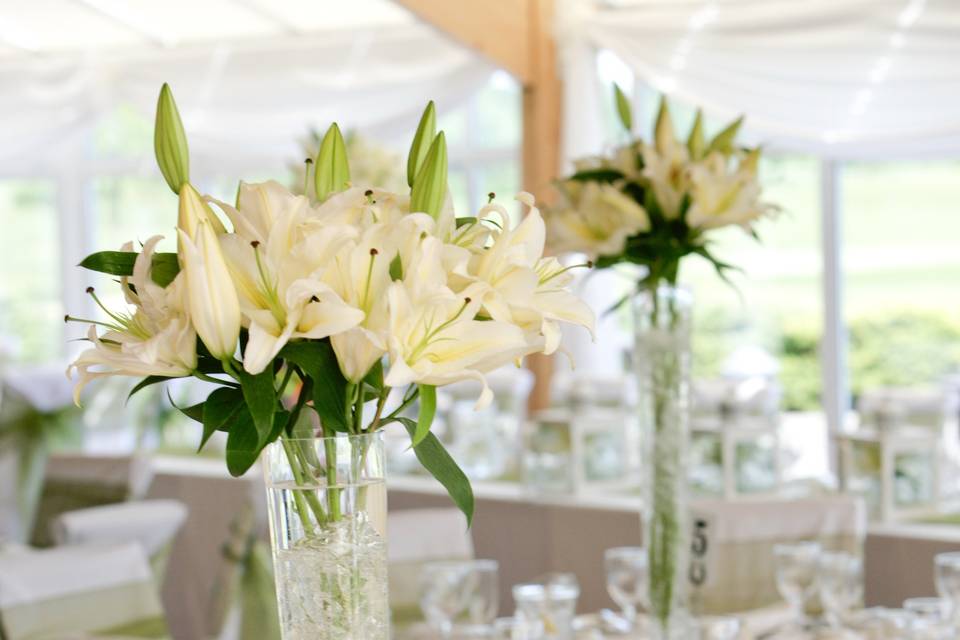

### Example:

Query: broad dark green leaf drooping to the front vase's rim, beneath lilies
xmin=279 ymin=340 xmax=350 ymax=432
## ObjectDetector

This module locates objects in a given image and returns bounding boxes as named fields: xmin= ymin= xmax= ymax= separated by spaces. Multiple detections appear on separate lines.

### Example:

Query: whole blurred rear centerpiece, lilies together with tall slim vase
xmin=546 ymin=87 xmax=775 ymax=640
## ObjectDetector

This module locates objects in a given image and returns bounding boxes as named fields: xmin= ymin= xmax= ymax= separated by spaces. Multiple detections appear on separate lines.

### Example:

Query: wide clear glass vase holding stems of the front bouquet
xmin=264 ymin=433 xmax=390 ymax=640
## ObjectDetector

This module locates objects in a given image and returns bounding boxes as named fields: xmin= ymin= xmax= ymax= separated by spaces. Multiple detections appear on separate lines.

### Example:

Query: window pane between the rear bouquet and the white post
xmin=681 ymin=157 xmax=822 ymax=410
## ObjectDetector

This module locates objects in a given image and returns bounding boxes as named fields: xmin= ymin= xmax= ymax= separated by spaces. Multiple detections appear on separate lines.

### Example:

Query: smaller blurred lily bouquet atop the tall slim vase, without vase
xmin=546 ymin=87 xmax=777 ymax=289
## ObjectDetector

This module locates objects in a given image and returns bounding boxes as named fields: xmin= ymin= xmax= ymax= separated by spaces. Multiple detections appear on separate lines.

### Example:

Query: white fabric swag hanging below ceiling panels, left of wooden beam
xmin=0 ymin=23 xmax=493 ymax=173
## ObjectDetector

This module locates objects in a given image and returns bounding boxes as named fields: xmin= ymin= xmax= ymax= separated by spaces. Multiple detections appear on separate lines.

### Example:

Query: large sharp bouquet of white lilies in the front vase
xmin=68 ymin=85 xmax=593 ymax=517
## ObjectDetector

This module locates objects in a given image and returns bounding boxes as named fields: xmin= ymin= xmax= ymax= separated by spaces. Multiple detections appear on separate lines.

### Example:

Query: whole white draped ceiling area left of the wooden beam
xmin=0 ymin=0 xmax=493 ymax=173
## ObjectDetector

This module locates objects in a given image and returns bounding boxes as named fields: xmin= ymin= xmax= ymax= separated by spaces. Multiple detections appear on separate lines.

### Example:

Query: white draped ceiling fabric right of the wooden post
xmin=559 ymin=0 xmax=960 ymax=159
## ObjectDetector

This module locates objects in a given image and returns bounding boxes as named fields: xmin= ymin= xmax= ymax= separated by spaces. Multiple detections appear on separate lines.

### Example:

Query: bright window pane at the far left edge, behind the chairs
xmin=0 ymin=180 xmax=63 ymax=362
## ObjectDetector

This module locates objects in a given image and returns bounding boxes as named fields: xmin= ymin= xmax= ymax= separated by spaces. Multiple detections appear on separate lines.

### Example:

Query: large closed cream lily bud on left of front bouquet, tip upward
xmin=177 ymin=220 xmax=240 ymax=359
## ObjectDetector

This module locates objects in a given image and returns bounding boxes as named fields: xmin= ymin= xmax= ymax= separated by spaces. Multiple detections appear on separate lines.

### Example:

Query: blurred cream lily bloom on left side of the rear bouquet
xmin=546 ymin=181 xmax=650 ymax=258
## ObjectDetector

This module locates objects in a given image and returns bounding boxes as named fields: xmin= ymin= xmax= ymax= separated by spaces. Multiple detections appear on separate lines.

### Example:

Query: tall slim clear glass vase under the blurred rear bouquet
xmin=633 ymin=286 xmax=692 ymax=640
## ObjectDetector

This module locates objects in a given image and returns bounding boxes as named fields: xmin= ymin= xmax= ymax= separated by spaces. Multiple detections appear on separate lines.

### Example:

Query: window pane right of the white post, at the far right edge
xmin=841 ymin=162 xmax=960 ymax=399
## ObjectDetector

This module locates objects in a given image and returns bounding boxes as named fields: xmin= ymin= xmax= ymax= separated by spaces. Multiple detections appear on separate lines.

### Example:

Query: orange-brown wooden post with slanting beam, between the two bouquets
xmin=397 ymin=0 xmax=562 ymax=410
